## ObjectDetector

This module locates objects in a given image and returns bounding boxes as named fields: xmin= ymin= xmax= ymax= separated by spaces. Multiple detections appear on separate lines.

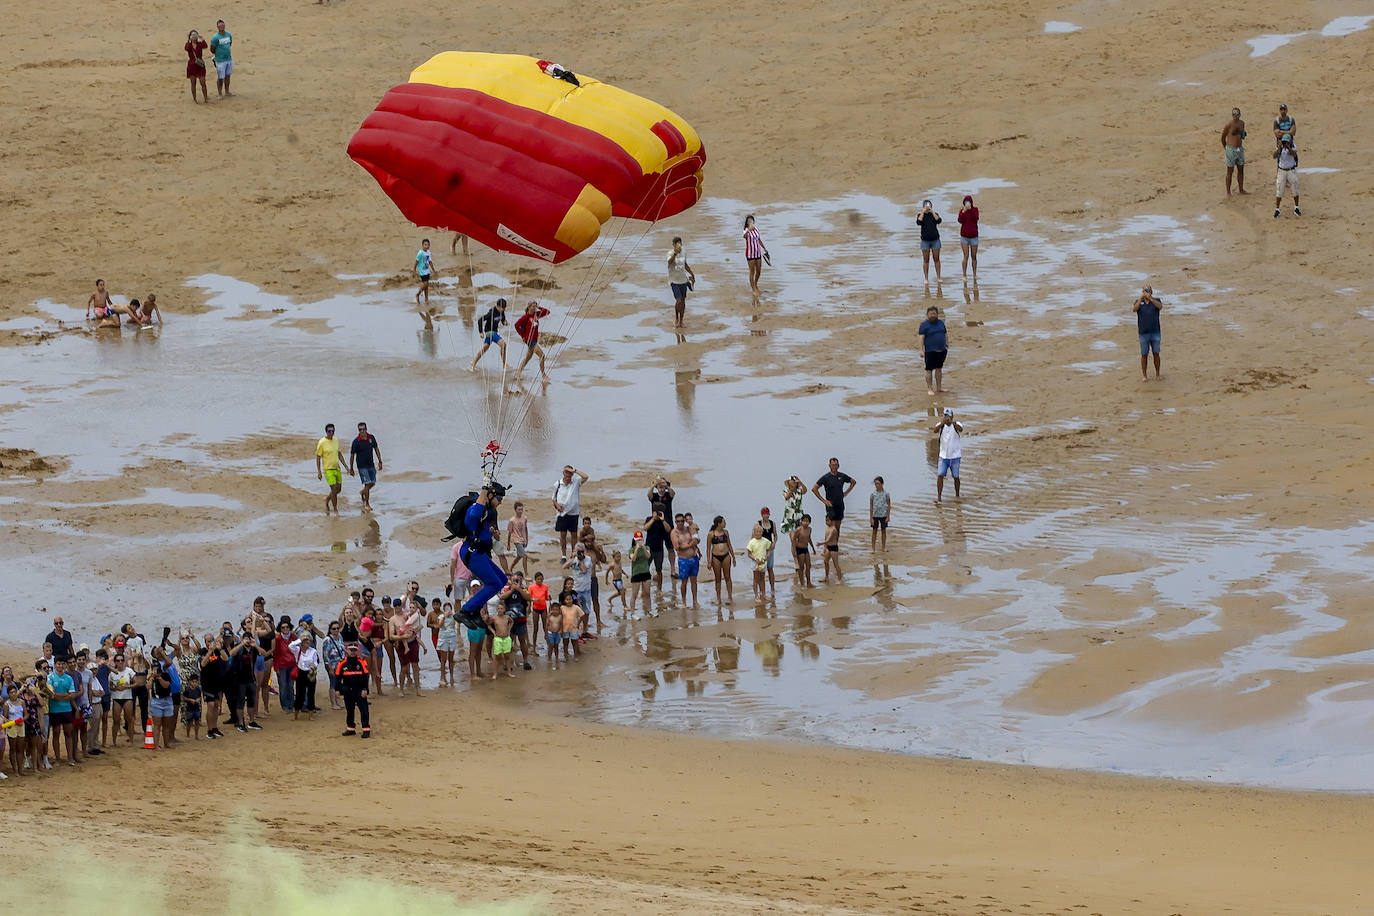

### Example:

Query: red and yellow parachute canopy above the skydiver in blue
xmin=348 ymin=51 xmax=706 ymax=262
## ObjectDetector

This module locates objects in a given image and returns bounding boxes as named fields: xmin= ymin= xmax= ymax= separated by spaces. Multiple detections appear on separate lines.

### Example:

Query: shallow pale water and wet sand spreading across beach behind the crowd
xmin=0 ymin=192 xmax=1374 ymax=788
